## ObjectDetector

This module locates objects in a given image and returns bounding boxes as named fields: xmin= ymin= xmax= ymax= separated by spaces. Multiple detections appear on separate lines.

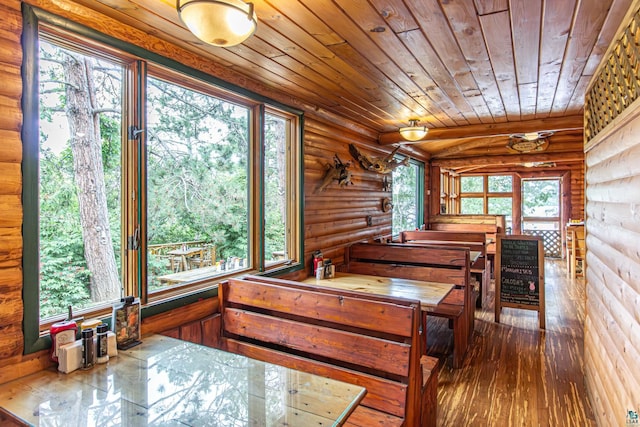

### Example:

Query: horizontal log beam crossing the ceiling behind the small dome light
xmin=378 ymin=115 xmax=584 ymax=145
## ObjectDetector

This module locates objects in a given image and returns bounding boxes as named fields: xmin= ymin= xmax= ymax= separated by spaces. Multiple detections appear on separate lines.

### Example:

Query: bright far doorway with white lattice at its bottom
xmin=522 ymin=178 xmax=562 ymax=258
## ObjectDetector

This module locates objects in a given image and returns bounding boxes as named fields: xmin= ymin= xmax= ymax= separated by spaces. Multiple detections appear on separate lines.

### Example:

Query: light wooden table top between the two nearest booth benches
xmin=304 ymin=273 xmax=453 ymax=311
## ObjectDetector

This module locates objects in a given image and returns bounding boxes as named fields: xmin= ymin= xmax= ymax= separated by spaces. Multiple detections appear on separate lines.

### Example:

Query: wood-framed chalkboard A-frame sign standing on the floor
xmin=495 ymin=235 xmax=545 ymax=329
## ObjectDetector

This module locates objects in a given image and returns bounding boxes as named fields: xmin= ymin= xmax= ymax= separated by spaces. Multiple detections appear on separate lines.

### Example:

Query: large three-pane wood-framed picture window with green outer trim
xmin=23 ymin=13 xmax=302 ymax=351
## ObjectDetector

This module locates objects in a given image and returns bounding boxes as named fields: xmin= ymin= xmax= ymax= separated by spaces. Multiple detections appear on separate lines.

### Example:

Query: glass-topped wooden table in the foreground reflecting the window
xmin=0 ymin=335 xmax=366 ymax=427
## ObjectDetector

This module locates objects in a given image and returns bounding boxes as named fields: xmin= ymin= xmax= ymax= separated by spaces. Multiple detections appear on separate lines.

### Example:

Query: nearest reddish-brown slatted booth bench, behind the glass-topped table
xmin=218 ymin=276 xmax=438 ymax=427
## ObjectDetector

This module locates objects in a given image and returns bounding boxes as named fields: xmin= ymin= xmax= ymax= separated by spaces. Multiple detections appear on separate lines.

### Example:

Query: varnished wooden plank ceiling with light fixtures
xmin=69 ymin=0 xmax=634 ymax=168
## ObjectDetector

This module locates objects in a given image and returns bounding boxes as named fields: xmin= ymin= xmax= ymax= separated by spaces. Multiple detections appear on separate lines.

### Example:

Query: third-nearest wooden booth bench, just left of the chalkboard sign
xmin=400 ymin=230 xmax=491 ymax=308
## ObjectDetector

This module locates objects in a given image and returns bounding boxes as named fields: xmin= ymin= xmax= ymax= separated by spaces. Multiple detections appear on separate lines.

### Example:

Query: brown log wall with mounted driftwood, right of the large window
xmin=304 ymin=118 xmax=404 ymax=275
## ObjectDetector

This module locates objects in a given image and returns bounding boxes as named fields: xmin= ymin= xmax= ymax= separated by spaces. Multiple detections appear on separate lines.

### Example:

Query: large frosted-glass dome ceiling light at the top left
xmin=176 ymin=0 xmax=258 ymax=47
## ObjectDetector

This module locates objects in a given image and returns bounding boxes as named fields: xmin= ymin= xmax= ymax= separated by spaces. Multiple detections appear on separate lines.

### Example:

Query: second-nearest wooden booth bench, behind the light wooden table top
xmin=342 ymin=243 xmax=475 ymax=368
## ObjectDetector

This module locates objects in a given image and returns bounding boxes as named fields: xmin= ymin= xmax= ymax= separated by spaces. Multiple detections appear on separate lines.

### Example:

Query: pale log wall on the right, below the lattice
xmin=584 ymin=102 xmax=640 ymax=426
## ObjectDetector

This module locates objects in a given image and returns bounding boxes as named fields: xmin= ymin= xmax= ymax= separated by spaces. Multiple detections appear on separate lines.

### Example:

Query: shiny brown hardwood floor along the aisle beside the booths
xmin=427 ymin=260 xmax=595 ymax=427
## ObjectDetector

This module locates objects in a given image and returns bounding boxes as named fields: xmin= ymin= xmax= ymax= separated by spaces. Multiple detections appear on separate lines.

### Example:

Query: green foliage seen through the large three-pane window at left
xmin=39 ymin=39 xmax=289 ymax=318
